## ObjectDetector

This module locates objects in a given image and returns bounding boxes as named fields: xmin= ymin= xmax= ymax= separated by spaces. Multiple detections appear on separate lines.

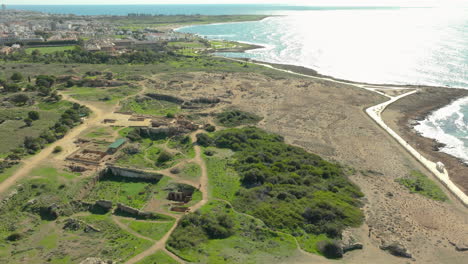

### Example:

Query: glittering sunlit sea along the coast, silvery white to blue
xmin=9 ymin=5 xmax=468 ymax=163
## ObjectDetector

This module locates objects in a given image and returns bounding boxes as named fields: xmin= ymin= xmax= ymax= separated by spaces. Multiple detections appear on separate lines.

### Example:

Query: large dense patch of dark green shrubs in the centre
xmin=198 ymin=127 xmax=363 ymax=255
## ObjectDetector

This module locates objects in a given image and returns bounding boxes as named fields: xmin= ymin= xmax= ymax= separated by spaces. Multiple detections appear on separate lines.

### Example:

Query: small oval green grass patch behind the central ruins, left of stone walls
xmin=120 ymin=97 xmax=180 ymax=116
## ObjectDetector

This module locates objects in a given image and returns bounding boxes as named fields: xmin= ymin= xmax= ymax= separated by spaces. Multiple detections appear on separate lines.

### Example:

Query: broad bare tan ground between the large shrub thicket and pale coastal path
xmin=152 ymin=73 xmax=468 ymax=263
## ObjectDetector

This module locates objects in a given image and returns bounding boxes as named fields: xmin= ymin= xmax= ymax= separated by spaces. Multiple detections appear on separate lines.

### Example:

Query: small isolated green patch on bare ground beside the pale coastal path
xmin=396 ymin=171 xmax=448 ymax=202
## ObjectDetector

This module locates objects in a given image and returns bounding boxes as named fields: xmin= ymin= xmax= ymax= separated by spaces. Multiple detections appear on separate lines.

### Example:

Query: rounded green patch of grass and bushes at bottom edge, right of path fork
xmin=168 ymin=201 xmax=297 ymax=263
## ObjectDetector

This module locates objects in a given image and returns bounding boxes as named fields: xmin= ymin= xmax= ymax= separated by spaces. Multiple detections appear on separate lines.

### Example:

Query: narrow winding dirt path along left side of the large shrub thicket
xmin=126 ymin=130 xmax=208 ymax=264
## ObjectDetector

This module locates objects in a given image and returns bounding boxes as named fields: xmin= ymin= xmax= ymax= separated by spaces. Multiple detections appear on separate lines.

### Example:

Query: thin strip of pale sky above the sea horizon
xmin=0 ymin=0 xmax=467 ymax=6
